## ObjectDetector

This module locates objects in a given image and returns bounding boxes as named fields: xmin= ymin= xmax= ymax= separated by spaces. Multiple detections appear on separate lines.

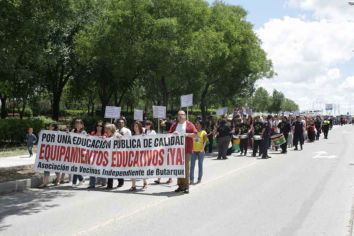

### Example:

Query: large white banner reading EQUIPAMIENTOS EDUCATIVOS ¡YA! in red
xmin=35 ymin=130 xmax=185 ymax=178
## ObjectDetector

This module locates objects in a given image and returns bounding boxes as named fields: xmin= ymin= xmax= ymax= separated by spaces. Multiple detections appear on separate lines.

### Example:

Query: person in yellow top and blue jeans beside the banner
xmin=190 ymin=120 xmax=208 ymax=184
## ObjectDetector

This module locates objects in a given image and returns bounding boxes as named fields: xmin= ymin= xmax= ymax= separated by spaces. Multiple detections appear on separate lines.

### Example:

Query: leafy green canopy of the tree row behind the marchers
xmin=0 ymin=0 xmax=280 ymax=119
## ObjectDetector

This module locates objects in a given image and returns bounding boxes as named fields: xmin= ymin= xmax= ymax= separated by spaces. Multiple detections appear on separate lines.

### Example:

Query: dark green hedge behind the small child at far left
xmin=0 ymin=117 xmax=53 ymax=145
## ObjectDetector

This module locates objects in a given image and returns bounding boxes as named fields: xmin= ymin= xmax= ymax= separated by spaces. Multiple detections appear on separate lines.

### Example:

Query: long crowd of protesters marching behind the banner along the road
xmin=27 ymin=110 xmax=345 ymax=193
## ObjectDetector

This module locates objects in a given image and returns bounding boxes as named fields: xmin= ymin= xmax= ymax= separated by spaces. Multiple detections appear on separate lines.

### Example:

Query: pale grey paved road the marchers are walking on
xmin=0 ymin=126 xmax=354 ymax=236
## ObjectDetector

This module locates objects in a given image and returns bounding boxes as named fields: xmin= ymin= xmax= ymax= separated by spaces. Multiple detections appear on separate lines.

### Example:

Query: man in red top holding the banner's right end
xmin=169 ymin=110 xmax=198 ymax=193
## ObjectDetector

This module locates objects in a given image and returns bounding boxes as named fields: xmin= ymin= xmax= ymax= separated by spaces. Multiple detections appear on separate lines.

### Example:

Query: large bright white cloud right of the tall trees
xmin=256 ymin=0 xmax=354 ymax=113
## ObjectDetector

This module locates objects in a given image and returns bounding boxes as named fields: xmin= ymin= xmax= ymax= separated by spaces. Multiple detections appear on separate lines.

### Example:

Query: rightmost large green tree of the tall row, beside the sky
xmin=191 ymin=2 xmax=273 ymax=121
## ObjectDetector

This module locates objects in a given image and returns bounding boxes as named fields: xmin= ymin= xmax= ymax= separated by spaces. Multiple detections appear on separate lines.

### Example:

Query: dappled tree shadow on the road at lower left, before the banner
xmin=0 ymin=189 xmax=74 ymax=231
